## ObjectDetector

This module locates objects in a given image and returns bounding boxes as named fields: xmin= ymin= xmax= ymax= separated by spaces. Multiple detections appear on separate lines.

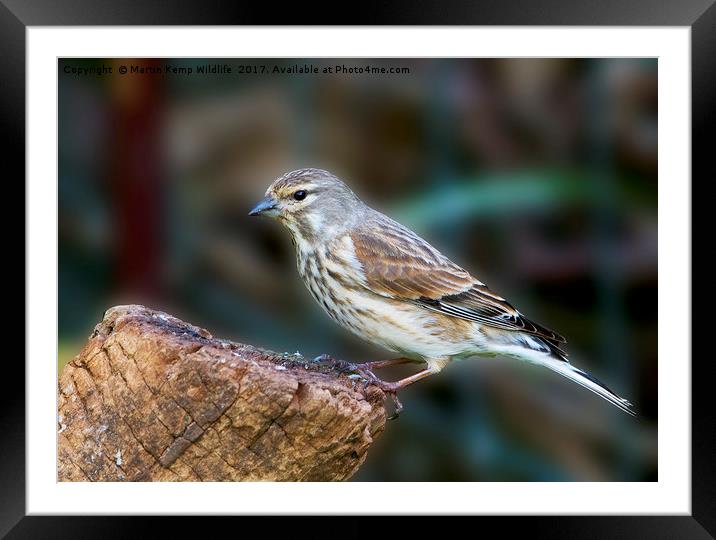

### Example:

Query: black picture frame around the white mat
xmin=0 ymin=0 xmax=716 ymax=539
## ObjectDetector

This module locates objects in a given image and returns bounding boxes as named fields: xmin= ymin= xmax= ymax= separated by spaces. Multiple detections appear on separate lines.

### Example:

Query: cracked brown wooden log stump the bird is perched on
xmin=57 ymin=306 xmax=386 ymax=481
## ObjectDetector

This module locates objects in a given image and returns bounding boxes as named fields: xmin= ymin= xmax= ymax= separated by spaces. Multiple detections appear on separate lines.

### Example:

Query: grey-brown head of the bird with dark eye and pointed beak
xmin=249 ymin=169 xmax=364 ymax=236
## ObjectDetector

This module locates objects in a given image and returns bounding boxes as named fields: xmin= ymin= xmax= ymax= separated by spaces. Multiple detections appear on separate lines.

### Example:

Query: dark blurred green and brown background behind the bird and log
xmin=59 ymin=59 xmax=657 ymax=481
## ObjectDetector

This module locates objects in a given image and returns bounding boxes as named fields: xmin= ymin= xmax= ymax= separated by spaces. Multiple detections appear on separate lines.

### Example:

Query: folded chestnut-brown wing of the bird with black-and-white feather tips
xmin=350 ymin=218 xmax=566 ymax=343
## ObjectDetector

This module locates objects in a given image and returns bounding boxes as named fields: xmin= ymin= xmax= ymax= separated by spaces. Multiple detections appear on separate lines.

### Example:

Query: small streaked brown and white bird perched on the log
xmin=249 ymin=168 xmax=635 ymax=418
